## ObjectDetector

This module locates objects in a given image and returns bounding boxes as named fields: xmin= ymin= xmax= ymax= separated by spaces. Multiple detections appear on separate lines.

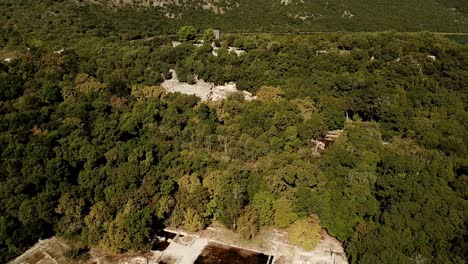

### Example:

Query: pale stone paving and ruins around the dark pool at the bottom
xmin=10 ymin=226 xmax=348 ymax=264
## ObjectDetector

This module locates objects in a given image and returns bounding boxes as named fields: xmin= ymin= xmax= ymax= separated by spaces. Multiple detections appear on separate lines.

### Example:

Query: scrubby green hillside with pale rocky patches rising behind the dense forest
xmin=0 ymin=0 xmax=468 ymax=45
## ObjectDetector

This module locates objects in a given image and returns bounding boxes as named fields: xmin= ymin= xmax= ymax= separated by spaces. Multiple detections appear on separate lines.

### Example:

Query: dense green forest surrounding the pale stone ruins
xmin=0 ymin=27 xmax=468 ymax=263
